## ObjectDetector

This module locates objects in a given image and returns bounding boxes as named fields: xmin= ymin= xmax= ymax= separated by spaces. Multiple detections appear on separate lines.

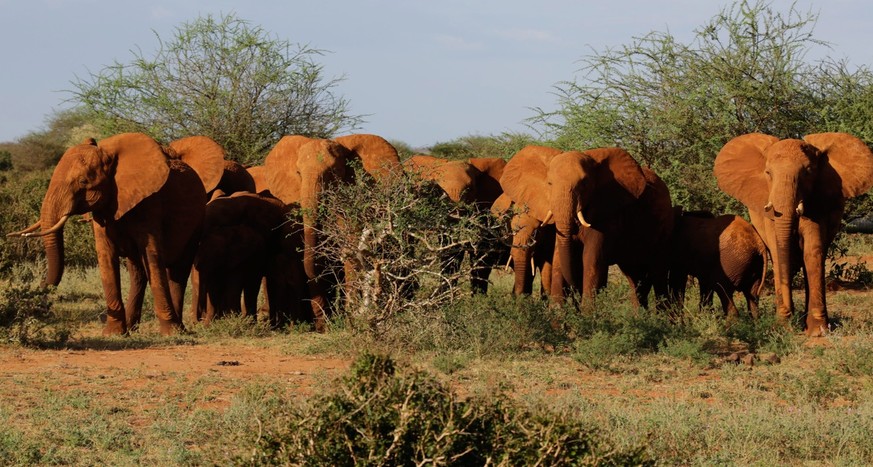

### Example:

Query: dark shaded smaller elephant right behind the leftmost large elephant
xmin=191 ymin=192 xmax=313 ymax=327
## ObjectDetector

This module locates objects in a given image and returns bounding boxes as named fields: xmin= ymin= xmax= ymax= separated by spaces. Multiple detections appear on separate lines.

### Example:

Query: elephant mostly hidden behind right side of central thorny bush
xmin=403 ymin=155 xmax=509 ymax=293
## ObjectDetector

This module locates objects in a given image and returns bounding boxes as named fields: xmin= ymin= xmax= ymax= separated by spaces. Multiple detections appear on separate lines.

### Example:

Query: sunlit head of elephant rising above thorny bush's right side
xmin=403 ymin=154 xmax=481 ymax=203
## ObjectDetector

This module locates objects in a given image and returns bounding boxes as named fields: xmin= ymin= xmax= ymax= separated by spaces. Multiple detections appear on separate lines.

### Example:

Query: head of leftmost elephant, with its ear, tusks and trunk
xmin=24 ymin=133 xmax=170 ymax=285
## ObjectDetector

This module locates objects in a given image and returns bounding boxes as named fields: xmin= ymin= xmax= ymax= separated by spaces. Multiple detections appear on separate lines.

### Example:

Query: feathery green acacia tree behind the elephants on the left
xmin=71 ymin=14 xmax=361 ymax=163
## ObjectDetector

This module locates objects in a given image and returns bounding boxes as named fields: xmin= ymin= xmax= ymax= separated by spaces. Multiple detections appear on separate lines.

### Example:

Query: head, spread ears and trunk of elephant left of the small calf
xmin=500 ymin=146 xmax=646 ymax=285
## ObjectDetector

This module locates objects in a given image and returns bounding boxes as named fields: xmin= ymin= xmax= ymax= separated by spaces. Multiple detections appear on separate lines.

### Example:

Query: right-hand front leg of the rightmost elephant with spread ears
xmin=798 ymin=219 xmax=828 ymax=337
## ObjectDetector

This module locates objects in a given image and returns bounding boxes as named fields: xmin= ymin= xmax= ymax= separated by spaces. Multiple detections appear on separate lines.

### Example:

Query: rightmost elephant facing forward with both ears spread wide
xmin=713 ymin=133 xmax=873 ymax=337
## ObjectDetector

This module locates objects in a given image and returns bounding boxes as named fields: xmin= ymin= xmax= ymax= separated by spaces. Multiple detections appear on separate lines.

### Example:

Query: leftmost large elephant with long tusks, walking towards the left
xmin=10 ymin=133 xmax=223 ymax=335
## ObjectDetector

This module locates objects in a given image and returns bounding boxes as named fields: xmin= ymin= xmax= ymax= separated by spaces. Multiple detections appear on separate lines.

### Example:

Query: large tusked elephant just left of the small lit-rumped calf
xmin=500 ymin=146 xmax=673 ymax=307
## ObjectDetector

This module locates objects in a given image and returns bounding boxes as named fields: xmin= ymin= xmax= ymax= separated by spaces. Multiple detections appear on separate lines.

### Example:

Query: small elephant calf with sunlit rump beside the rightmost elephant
xmin=669 ymin=207 xmax=767 ymax=319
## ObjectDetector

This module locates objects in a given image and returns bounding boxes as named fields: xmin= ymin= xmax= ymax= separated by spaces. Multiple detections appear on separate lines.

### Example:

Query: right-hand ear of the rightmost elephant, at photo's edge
xmin=803 ymin=133 xmax=873 ymax=198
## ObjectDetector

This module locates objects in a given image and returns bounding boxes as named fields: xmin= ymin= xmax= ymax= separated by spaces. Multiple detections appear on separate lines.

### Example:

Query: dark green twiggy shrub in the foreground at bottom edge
xmin=249 ymin=354 xmax=651 ymax=466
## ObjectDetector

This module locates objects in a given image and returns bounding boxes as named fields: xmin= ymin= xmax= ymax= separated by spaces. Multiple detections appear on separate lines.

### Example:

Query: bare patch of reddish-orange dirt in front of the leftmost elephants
xmin=0 ymin=343 xmax=349 ymax=408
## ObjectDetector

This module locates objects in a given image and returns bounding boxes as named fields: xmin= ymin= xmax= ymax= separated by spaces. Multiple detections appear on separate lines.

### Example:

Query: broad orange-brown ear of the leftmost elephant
xmin=97 ymin=133 xmax=170 ymax=220
